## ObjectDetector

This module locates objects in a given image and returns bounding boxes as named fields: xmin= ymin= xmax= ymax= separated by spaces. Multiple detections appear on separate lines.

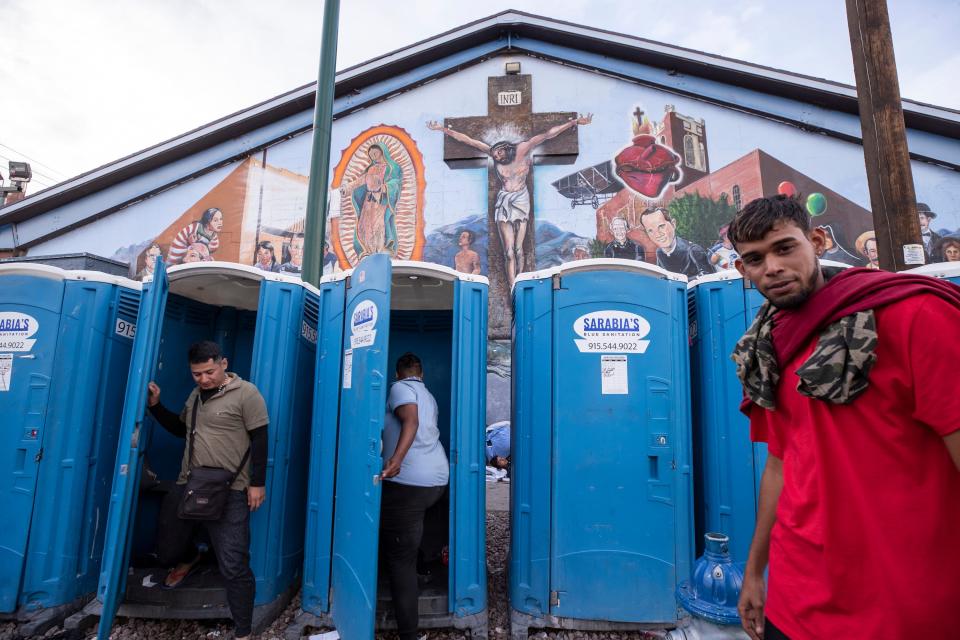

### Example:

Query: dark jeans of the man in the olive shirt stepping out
xmin=157 ymin=485 xmax=256 ymax=637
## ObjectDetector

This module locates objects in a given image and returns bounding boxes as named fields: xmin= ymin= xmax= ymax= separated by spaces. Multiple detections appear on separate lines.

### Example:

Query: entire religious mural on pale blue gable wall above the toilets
xmin=31 ymin=56 xmax=960 ymax=430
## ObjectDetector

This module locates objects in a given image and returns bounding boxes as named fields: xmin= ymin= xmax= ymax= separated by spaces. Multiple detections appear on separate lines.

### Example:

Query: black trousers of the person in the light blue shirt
xmin=380 ymin=481 xmax=447 ymax=640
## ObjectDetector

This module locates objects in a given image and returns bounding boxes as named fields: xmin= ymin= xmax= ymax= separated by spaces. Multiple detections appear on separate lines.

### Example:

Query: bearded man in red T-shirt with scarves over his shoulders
xmin=728 ymin=196 xmax=960 ymax=640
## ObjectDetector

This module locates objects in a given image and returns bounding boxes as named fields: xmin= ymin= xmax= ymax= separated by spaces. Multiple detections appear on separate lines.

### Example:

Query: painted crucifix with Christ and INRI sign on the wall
xmin=427 ymin=75 xmax=591 ymax=338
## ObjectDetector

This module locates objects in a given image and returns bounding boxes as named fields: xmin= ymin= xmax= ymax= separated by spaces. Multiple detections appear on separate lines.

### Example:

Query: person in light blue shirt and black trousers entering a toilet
xmin=380 ymin=353 xmax=450 ymax=640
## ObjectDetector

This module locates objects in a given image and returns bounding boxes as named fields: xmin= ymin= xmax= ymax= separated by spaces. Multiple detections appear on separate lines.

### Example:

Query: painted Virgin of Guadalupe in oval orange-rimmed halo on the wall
xmin=330 ymin=125 xmax=426 ymax=269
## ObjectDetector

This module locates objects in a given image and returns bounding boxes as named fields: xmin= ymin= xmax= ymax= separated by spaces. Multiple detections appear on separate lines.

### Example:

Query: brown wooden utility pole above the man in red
xmin=846 ymin=0 xmax=924 ymax=271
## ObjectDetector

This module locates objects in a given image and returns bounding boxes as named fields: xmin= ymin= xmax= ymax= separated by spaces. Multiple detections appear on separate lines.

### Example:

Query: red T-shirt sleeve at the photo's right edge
xmin=907 ymin=295 xmax=960 ymax=436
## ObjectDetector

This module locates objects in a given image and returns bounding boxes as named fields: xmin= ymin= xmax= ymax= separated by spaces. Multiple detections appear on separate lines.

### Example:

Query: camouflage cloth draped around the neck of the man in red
xmin=730 ymin=302 xmax=877 ymax=411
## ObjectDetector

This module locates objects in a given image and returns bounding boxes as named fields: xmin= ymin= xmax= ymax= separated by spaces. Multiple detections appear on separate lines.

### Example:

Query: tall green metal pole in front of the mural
xmin=302 ymin=0 xmax=340 ymax=286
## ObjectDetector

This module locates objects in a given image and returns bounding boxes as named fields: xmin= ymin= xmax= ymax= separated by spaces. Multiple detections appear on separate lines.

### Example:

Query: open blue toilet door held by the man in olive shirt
xmin=97 ymin=259 xmax=170 ymax=640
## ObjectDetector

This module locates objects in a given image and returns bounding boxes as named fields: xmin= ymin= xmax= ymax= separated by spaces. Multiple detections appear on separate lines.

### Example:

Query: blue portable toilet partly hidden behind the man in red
xmin=688 ymin=260 xmax=850 ymax=563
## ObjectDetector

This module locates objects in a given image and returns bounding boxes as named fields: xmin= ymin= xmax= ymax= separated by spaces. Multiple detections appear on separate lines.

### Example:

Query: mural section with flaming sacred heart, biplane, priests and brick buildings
xmin=568 ymin=105 xmax=892 ymax=278
